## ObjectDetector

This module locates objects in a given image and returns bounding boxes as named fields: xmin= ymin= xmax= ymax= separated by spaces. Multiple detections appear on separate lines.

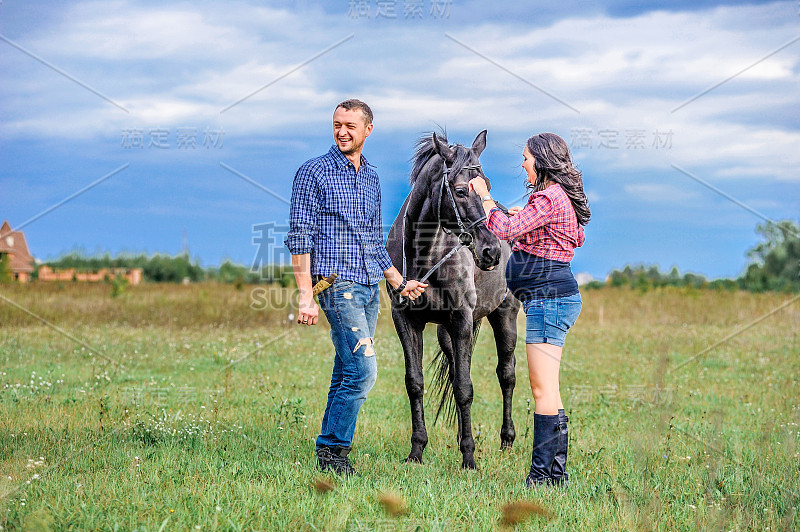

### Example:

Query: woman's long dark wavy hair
xmin=526 ymin=133 xmax=592 ymax=225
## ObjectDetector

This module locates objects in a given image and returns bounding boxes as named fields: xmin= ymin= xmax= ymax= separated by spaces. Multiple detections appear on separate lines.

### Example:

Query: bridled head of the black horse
xmin=431 ymin=130 xmax=500 ymax=270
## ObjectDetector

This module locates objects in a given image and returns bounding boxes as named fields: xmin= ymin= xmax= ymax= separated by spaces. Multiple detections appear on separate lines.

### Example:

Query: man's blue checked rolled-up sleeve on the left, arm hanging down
xmin=283 ymin=164 xmax=322 ymax=255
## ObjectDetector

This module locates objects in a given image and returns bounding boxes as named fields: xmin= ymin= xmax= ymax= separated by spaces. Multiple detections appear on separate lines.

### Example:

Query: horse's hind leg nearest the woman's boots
xmin=487 ymin=295 xmax=519 ymax=449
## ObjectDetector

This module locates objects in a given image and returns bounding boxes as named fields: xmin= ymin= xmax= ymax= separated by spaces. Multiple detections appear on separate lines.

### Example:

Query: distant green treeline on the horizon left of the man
xmin=34 ymin=253 xmax=294 ymax=286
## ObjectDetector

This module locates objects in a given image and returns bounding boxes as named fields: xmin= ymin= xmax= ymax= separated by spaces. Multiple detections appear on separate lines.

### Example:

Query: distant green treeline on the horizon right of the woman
xmin=600 ymin=220 xmax=800 ymax=292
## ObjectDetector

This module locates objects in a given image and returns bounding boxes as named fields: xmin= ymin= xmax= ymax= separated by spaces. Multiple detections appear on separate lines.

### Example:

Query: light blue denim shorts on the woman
xmin=522 ymin=293 xmax=583 ymax=347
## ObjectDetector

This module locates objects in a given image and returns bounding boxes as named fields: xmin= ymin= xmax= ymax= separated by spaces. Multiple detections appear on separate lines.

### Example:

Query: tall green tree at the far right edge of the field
xmin=739 ymin=220 xmax=800 ymax=291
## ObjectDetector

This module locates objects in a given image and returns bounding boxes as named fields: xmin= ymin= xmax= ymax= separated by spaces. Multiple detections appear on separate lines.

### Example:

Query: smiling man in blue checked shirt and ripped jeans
xmin=285 ymin=100 xmax=428 ymax=475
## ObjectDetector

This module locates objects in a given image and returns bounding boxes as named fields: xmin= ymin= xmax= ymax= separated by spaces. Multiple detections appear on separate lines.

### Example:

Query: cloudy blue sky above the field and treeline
xmin=0 ymin=0 xmax=800 ymax=279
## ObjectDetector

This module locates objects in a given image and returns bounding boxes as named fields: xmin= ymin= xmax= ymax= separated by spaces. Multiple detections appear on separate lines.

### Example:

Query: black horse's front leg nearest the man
xmin=392 ymin=309 xmax=428 ymax=463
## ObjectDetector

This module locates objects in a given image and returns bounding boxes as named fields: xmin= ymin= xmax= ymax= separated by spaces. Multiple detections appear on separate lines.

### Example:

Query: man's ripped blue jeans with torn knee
xmin=317 ymin=280 xmax=380 ymax=447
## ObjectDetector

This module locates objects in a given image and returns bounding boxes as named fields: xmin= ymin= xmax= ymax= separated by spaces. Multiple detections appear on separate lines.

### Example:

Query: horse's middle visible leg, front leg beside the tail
xmin=445 ymin=311 xmax=475 ymax=469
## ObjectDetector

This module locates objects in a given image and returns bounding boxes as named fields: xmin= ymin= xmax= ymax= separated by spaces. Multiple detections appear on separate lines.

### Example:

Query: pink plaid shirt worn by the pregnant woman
xmin=486 ymin=183 xmax=585 ymax=262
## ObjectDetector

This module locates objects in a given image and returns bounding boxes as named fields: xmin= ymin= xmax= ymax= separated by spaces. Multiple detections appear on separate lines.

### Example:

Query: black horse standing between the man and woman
xmin=386 ymin=131 xmax=520 ymax=469
